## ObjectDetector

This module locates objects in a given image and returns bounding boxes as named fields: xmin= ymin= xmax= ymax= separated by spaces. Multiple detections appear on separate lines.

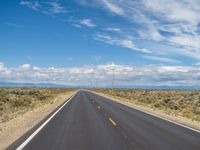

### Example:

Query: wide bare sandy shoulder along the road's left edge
xmin=0 ymin=92 xmax=74 ymax=150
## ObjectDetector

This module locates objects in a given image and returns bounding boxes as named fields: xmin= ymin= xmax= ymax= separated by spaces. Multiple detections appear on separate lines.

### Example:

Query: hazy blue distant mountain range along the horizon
xmin=0 ymin=81 xmax=200 ymax=90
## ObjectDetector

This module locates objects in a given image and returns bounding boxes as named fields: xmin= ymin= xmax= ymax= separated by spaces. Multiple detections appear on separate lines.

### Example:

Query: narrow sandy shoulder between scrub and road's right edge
xmin=92 ymin=91 xmax=200 ymax=130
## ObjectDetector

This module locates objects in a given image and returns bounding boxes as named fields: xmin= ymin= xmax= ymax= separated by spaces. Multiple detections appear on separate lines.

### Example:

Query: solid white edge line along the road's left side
xmin=16 ymin=90 xmax=79 ymax=150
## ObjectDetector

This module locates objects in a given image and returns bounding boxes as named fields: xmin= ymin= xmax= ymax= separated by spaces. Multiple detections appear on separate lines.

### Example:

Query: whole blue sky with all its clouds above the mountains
xmin=0 ymin=0 xmax=200 ymax=86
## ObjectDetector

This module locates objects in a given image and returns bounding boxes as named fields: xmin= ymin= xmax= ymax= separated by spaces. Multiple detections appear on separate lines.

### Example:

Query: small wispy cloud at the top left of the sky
xmin=20 ymin=1 xmax=67 ymax=14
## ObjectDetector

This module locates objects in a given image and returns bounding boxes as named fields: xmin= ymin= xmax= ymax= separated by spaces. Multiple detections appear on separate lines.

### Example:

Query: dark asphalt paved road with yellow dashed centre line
xmin=11 ymin=91 xmax=200 ymax=150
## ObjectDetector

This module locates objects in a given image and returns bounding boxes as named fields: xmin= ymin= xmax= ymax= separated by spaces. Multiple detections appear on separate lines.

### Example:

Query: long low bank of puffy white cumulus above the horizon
xmin=0 ymin=63 xmax=200 ymax=86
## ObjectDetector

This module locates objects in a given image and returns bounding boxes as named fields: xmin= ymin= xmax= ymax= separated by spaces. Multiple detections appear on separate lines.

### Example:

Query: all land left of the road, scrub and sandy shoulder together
xmin=0 ymin=88 xmax=77 ymax=149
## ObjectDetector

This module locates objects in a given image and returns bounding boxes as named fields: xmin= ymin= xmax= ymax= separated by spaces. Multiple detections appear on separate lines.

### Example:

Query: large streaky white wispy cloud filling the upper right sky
xmin=79 ymin=0 xmax=200 ymax=59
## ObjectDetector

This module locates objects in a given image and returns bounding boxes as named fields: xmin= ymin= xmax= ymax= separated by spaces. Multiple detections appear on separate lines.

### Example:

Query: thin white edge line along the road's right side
xmin=88 ymin=90 xmax=200 ymax=133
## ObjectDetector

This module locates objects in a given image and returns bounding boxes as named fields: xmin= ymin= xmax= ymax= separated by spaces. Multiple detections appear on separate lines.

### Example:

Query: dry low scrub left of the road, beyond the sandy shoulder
xmin=0 ymin=88 xmax=75 ymax=123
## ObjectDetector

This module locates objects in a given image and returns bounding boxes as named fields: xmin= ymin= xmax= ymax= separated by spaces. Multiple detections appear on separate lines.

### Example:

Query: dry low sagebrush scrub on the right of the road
xmin=92 ymin=89 xmax=200 ymax=121
